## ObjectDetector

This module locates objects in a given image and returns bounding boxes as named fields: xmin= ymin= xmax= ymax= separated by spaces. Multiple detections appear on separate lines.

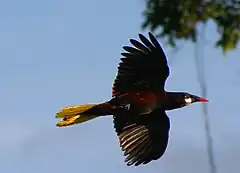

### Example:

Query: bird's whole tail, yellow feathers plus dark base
xmin=56 ymin=103 xmax=111 ymax=127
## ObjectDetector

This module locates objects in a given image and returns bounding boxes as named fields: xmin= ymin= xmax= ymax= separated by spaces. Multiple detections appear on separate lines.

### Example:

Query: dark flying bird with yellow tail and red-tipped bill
xmin=56 ymin=32 xmax=208 ymax=166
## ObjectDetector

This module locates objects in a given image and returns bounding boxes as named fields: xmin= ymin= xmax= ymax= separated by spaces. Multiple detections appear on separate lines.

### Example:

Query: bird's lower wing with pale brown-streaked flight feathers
xmin=113 ymin=109 xmax=170 ymax=166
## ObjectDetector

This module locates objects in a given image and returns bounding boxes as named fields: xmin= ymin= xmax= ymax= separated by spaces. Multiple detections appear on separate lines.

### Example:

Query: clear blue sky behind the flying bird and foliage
xmin=0 ymin=0 xmax=240 ymax=173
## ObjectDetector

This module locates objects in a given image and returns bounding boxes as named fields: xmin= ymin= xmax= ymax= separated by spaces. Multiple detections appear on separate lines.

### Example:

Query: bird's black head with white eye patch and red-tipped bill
xmin=164 ymin=92 xmax=208 ymax=110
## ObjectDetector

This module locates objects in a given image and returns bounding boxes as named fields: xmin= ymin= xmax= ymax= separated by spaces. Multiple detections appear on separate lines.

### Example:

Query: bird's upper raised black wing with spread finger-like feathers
xmin=112 ymin=32 xmax=169 ymax=96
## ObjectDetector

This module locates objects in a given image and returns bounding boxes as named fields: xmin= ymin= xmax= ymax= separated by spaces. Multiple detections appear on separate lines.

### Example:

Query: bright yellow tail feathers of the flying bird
xmin=56 ymin=104 xmax=98 ymax=127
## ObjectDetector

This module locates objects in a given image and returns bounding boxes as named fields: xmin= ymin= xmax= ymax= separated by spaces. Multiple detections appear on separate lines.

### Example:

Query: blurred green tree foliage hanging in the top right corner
xmin=142 ymin=0 xmax=240 ymax=53
